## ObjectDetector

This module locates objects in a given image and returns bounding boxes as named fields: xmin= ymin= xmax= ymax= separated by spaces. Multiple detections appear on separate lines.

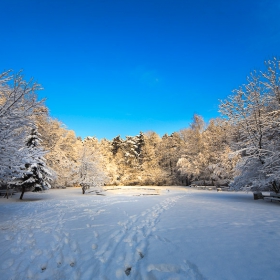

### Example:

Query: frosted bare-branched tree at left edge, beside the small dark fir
xmin=0 ymin=71 xmax=47 ymax=190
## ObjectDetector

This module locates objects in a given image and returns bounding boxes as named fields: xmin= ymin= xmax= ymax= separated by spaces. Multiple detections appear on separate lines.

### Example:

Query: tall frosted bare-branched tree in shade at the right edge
xmin=220 ymin=58 xmax=280 ymax=192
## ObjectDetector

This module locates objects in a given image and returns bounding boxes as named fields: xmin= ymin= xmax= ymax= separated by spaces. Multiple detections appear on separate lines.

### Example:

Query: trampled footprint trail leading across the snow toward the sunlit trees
xmin=92 ymin=195 xmax=195 ymax=279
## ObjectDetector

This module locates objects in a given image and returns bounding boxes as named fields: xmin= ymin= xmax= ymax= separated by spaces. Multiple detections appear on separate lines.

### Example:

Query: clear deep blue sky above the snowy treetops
xmin=0 ymin=0 xmax=280 ymax=139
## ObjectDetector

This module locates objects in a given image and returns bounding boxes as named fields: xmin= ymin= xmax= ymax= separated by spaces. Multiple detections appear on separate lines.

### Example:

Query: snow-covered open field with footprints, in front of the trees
xmin=0 ymin=187 xmax=280 ymax=280
